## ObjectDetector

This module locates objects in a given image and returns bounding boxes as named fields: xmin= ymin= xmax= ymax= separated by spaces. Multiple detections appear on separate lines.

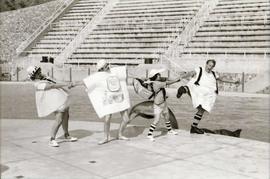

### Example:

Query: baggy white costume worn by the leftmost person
xmin=35 ymin=81 xmax=68 ymax=117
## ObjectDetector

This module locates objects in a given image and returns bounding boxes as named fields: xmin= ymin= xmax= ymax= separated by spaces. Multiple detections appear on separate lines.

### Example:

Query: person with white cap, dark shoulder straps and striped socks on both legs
xmin=145 ymin=68 xmax=180 ymax=141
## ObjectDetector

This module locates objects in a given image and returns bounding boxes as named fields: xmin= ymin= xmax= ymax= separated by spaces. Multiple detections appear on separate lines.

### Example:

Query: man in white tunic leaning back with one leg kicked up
xmin=177 ymin=59 xmax=239 ymax=134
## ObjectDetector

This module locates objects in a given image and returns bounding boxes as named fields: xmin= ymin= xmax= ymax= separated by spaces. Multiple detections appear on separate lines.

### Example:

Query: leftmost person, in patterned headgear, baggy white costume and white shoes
xmin=27 ymin=66 xmax=77 ymax=147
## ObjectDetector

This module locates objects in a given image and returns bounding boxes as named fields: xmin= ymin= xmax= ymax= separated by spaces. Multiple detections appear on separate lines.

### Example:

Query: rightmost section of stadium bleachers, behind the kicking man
xmin=184 ymin=0 xmax=270 ymax=57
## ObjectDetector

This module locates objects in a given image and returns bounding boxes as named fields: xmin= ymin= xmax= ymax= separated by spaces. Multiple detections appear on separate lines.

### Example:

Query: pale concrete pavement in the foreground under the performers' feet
xmin=1 ymin=119 xmax=269 ymax=179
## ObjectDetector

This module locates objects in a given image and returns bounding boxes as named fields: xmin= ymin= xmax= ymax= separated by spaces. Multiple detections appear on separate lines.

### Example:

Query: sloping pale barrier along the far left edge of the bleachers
xmin=16 ymin=0 xmax=74 ymax=55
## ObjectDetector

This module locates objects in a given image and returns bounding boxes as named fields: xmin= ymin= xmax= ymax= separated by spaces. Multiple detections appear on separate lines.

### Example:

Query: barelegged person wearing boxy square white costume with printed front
xmin=75 ymin=60 xmax=130 ymax=144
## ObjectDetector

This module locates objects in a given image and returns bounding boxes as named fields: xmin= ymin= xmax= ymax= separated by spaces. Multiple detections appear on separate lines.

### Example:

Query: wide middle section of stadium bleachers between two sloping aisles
xmin=68 ymin=0 xmax=205 ymax=64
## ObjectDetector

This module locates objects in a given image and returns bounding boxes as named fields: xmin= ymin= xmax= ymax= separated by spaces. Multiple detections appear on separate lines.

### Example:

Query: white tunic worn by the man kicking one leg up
xmin=187 ymin=68 xmax=218 ymax=112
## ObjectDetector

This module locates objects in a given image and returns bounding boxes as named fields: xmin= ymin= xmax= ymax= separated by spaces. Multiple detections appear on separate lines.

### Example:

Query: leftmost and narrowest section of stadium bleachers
xmin=17 ymin=0 xmax=107 ymax=59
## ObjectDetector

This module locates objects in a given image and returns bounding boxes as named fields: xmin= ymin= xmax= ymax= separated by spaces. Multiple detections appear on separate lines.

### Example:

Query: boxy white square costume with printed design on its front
xmin=83 ymin=67 xmax=130 ymax=118
